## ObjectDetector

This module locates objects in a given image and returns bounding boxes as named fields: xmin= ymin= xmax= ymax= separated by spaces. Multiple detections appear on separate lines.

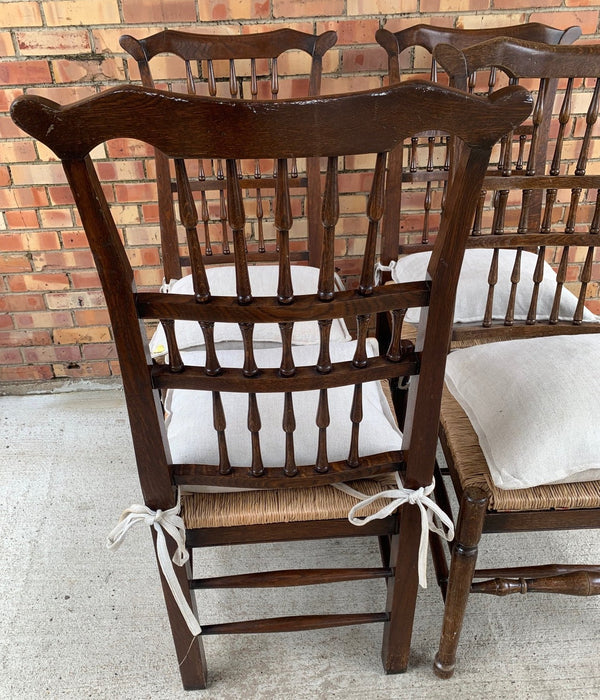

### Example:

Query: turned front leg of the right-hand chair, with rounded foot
xmin=433 ymin=488 xmax=488 ymax=678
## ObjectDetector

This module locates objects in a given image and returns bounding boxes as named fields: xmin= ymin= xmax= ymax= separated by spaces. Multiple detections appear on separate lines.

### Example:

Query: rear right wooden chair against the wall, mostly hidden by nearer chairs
xmin=375 ymin=22 xmax=581 ymax=265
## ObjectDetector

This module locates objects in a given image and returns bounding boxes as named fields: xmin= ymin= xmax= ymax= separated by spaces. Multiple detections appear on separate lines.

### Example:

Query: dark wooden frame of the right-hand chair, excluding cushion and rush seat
xmin=434 ymin=39 xmax=600 ymax=678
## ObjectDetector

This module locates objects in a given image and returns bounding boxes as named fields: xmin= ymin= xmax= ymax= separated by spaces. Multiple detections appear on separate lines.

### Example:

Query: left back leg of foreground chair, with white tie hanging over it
xmin=152 ymin=530 xmax=207 ymax=690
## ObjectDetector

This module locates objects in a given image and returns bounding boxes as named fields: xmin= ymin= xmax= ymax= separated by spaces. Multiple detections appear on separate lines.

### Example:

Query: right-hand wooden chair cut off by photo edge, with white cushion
xmin=407 ymin=40 xmax=600 ymax=678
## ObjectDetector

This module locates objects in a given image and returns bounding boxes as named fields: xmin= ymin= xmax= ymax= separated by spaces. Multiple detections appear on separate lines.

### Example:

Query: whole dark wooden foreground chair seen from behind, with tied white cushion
xmin=12 ymin=82 xmax=532 ymax=688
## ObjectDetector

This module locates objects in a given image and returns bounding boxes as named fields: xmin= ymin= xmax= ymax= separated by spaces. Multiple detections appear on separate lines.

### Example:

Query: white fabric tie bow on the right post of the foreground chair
xmin=332 ymin=473 xmax=454 ymax=588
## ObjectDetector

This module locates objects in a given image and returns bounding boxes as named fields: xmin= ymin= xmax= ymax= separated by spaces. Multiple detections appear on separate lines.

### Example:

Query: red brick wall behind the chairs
xmin=0 ymin=0 xmax=600 ymax=382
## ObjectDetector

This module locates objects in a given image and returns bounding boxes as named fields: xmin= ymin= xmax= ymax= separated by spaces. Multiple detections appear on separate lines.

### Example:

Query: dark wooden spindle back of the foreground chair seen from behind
xmin=12 ymin=82 xmax=531 ymax=509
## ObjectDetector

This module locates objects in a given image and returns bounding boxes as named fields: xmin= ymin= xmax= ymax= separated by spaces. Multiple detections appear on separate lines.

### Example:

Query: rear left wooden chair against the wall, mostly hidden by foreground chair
xmin=119 ymin=29 xmax=337 ymax=282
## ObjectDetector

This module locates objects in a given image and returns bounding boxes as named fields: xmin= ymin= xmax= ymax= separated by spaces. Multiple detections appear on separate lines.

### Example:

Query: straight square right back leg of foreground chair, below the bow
xmin=381 ymin=506 xmax=421 ymax=673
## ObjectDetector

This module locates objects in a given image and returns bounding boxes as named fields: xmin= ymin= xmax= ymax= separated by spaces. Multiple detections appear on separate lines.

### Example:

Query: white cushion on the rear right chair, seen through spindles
xmin=392 ymin=248 xmax=598 ymax=323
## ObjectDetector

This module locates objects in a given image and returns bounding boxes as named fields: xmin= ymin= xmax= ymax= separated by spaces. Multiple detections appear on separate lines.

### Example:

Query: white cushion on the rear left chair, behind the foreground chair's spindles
xmin=150 ymin=265 xmax=350 ymax=357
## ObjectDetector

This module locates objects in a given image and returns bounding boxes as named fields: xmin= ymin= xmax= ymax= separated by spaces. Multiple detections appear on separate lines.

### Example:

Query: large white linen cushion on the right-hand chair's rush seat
xmin=446 ymin=334 xmax=600 ymax=489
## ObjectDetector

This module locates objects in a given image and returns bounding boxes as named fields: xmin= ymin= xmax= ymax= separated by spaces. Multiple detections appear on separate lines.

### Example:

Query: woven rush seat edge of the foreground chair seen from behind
xmin=181 ymin=476 xmax=395 ymax=529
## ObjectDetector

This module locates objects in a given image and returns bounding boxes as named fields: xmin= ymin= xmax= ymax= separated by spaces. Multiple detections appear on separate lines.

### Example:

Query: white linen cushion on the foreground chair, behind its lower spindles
xmin=165 ymin=340 xmax=402 ymax=492
